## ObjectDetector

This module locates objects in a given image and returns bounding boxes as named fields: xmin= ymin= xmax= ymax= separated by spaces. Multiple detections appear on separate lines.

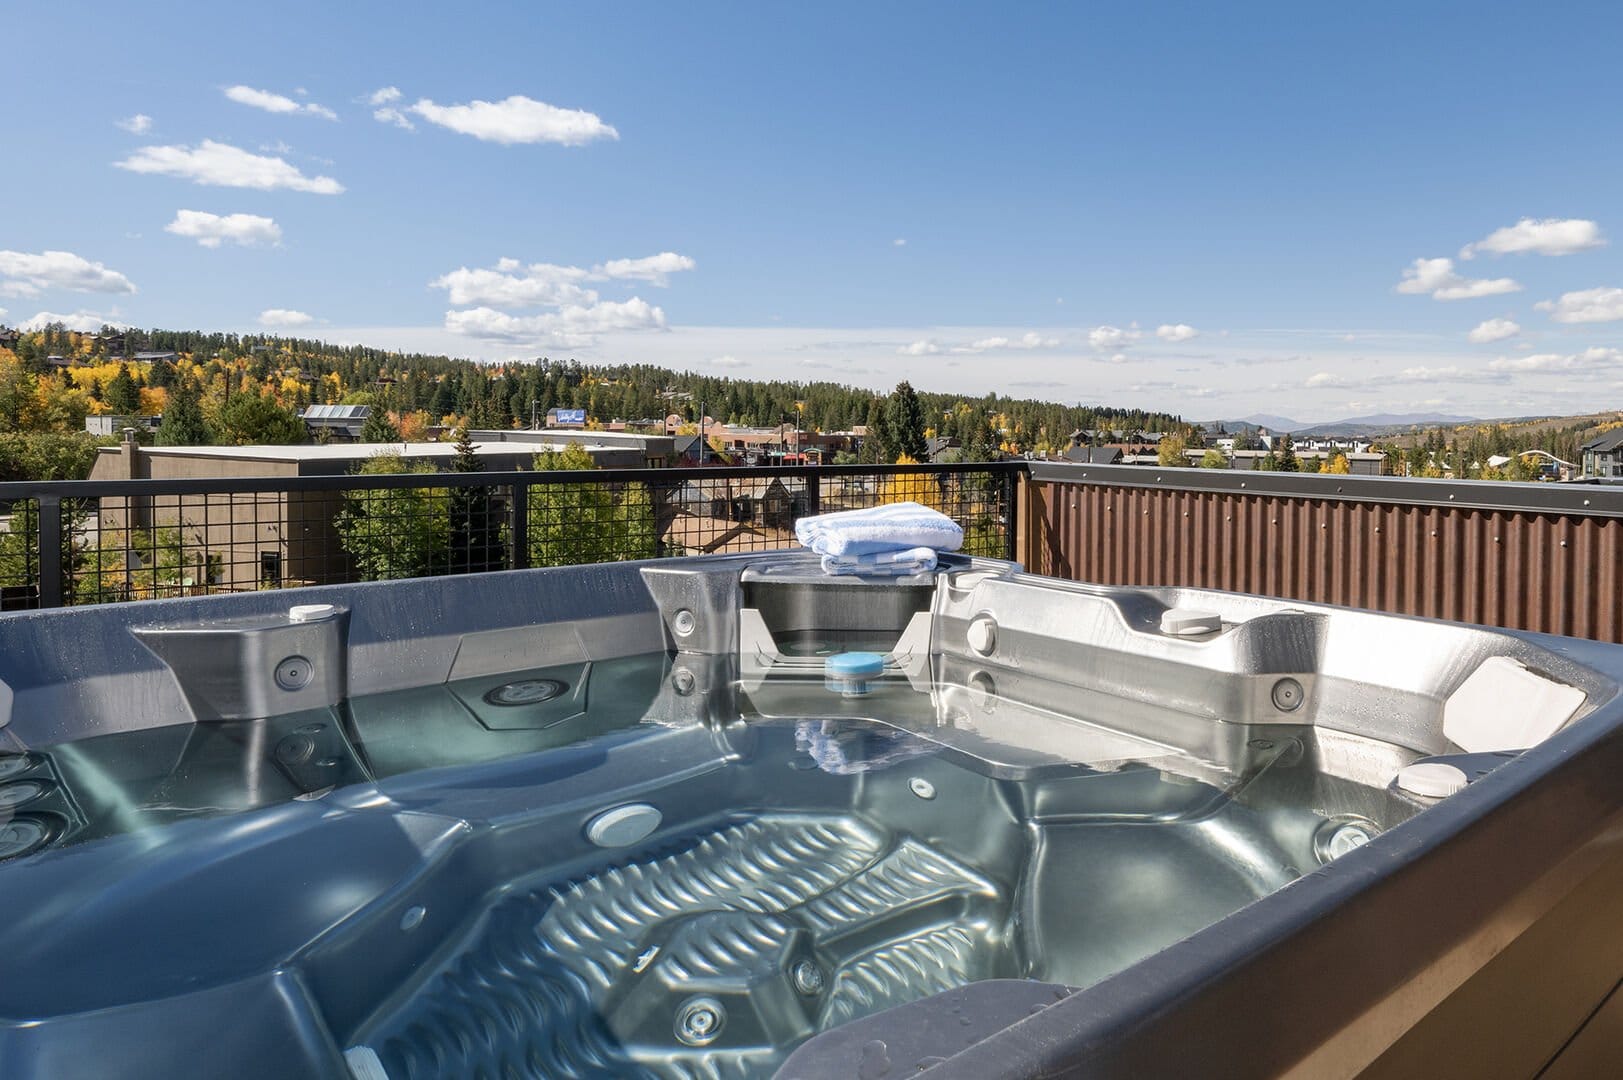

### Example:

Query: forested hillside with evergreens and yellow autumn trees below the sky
xmin=0 ymin=326 xmax=1178 ymax=479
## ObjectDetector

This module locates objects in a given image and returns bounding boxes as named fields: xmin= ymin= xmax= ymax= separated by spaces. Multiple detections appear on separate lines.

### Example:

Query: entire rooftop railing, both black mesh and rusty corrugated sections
xmin=0 ymin=461 xmax=1623 ymax=642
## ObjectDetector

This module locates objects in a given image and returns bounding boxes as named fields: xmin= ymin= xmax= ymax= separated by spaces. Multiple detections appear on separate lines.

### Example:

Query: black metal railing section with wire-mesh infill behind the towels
xmin=0 ymin=463 xmax=1024 ymax=609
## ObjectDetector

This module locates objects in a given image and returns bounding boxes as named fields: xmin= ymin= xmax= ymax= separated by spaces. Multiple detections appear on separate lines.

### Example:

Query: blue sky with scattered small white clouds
xmin=0 ymin=3 xmax=1623 ymax=421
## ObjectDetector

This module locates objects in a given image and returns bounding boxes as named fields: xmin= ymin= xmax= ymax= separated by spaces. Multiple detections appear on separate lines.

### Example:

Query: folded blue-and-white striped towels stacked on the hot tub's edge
xmin=795 ymin=502 xmax=964 ymax=577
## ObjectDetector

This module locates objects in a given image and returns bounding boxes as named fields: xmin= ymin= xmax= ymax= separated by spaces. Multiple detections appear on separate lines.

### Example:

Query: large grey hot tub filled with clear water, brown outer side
xmin=0 ymin=554 xmax=1623 ymax=1080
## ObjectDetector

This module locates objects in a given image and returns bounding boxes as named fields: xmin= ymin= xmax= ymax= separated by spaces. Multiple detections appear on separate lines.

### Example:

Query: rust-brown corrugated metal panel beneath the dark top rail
xmin=1022 ymin=479 xmax=1623 ymax=642
